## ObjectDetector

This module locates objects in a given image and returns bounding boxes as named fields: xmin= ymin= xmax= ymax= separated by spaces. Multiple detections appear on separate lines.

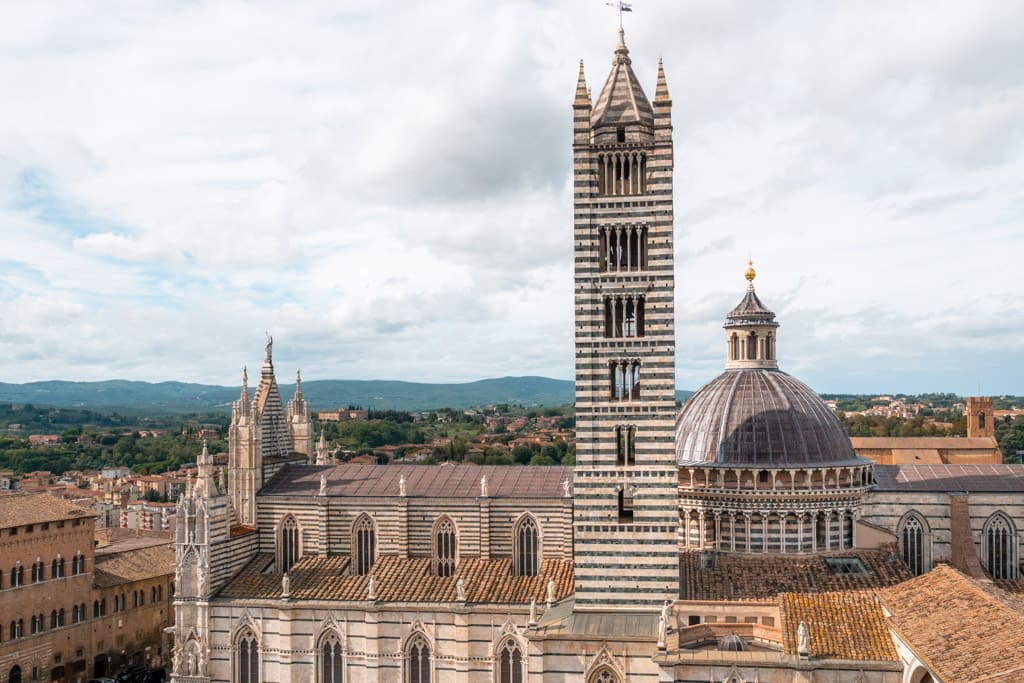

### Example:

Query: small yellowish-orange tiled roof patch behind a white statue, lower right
xmin=779 ymin=591 xmax=899 ymax=661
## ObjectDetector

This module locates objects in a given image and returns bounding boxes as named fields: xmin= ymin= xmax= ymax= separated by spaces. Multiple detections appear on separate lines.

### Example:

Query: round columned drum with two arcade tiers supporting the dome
xmin=679 ymin=465 xmax=871 ymax=553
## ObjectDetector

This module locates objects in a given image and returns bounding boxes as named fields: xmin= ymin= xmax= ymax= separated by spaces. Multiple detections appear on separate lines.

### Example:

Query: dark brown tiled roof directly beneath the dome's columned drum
xmin=679 ymin=550 xmax=913 ymax=600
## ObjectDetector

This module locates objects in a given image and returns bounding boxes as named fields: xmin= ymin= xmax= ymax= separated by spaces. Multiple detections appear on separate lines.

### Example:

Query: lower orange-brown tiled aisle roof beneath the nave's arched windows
xmin=220 ymin=553 xmax=573 ymax=604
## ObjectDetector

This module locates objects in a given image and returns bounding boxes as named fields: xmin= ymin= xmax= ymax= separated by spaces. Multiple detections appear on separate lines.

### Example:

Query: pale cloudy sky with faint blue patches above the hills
xmin=0 ymin=0 xmax=1024 ymax=395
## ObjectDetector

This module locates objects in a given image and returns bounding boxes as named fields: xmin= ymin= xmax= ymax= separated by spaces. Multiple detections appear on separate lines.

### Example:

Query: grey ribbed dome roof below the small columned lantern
xmin=676 ymin=369 xmax=862 ymax=467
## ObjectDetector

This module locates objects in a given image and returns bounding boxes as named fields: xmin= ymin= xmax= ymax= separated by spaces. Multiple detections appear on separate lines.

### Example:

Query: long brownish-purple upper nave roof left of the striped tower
xmin=260 ymin=464 xmax=572 ymax=499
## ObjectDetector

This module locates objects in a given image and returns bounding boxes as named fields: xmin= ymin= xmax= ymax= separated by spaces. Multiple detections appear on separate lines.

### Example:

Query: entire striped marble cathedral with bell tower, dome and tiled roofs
xmin=171 ymin=31 xmax=1024 ymax=683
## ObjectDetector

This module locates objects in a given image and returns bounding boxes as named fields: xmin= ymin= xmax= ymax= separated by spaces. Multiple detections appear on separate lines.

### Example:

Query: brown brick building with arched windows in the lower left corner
xmin=0 ymin=493 xmax=174 ymax=683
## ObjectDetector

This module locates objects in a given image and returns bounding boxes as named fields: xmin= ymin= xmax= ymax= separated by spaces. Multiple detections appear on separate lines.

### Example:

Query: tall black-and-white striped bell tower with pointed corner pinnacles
xmin=572 ymin=29 xmax=679 ymax=611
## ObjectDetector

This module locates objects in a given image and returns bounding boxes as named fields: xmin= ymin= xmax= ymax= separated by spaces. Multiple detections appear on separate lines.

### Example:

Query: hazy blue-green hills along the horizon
xmin=0 ymin=377 xmax=692 ymax=415
